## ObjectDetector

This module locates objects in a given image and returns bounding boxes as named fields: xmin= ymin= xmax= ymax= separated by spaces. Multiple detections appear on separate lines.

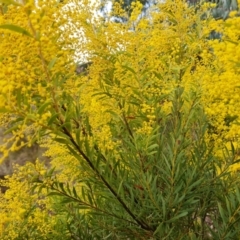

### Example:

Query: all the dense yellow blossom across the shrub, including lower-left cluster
xmin=0 ymin=0 xmax=240 ymax=239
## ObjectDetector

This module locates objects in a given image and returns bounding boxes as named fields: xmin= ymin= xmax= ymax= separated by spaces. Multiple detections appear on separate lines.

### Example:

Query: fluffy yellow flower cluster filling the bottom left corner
xmin=0 ymin=162 xmax=57 ymax=240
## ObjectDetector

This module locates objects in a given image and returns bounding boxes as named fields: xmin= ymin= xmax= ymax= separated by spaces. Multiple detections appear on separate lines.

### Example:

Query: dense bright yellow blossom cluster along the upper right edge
xmin=204 ymin=13 xmax=240 ymax=148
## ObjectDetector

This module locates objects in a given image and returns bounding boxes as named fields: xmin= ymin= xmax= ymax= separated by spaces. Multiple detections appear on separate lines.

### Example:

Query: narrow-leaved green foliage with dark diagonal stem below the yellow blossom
xmin=29 ymin=76 xmax=240 ymax=239
